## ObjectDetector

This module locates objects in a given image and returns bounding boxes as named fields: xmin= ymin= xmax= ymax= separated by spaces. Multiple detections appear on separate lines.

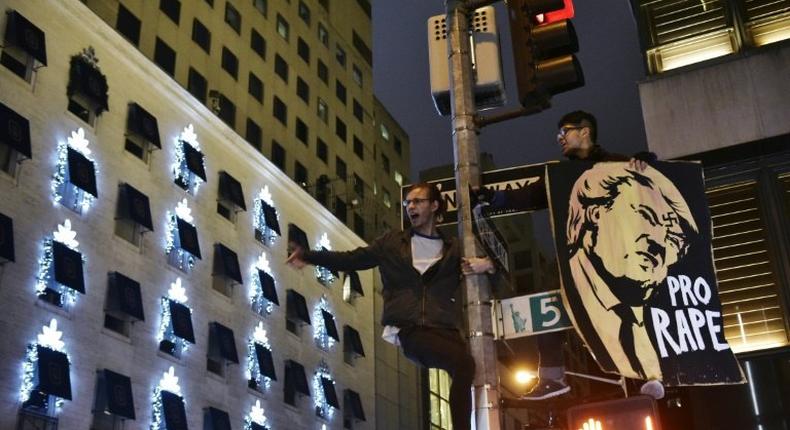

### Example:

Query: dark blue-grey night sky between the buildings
xmin=373 ymin=0 xmax=646 ymax=181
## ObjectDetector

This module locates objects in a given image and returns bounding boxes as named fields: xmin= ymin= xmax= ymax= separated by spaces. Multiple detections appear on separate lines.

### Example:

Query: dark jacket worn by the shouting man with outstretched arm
xmin=303 ymin=229 xmax=463 ymax=328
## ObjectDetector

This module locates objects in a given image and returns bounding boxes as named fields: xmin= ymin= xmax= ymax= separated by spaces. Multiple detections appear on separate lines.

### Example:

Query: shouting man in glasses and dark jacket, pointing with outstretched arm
xmin=287 ymin=183 xmax=494 ymax=430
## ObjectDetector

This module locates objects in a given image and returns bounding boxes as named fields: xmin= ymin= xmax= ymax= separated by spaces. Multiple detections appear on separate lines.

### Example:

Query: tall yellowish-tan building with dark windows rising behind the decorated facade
xmin=79 ymin=0 xmax=409 ymax=240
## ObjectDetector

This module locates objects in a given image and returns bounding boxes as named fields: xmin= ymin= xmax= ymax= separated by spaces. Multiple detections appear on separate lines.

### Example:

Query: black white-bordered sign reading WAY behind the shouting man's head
xmin=401 ymin=162 xmax=555 ymax=228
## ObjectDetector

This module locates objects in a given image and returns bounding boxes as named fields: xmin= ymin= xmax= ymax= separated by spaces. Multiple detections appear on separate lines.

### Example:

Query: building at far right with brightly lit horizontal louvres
xmin=631 ymin=0 xmax=790 ymax=429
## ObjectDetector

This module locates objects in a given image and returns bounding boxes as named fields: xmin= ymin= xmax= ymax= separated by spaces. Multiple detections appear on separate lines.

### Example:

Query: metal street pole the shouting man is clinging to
xmin=445 ymin=0 xmax=500 ymax=430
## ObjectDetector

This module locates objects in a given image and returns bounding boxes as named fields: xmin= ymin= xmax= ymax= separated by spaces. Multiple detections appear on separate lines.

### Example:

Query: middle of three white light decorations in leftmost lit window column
xmin=36 ymin=218 xmax=86 ymax=306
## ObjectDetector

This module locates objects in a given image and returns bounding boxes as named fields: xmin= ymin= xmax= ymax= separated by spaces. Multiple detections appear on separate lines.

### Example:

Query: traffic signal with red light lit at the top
xmin=508 ymin=0 xmax=584 ymax=107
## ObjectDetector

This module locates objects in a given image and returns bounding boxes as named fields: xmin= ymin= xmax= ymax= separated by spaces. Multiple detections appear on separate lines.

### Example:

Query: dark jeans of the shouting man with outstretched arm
xmin=398 ymin=327 xmax=475 ymax=430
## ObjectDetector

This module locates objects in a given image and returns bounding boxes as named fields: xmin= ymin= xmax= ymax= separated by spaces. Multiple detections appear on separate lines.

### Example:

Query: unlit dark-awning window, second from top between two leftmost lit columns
xmin=115 ymin=184 xmax=154 ymax=247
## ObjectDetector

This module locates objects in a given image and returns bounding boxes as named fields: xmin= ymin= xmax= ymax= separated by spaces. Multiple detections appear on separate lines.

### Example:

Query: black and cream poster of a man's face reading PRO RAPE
xmin=546 ymin=161 xmax=745 ymax=386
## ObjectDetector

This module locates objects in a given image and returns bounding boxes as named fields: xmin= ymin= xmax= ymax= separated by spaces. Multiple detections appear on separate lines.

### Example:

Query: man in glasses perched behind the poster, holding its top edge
xmin=480 ymin=110 xmax=663 ymax=400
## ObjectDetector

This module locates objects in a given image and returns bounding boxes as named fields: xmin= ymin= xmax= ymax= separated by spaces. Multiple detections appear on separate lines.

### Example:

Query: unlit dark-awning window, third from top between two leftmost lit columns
xmin=104 ymin=272 xmax=145 ymax=337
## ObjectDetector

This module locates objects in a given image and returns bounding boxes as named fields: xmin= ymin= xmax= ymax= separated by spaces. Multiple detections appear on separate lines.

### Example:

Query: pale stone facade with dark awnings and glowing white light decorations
xmin=0 ymin=0 xmax=377 ymax=430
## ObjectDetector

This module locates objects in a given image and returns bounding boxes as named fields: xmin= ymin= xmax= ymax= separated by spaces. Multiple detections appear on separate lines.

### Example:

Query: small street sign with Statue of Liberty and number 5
xmin=493 ymin=290 xmax=572 ymax=339
